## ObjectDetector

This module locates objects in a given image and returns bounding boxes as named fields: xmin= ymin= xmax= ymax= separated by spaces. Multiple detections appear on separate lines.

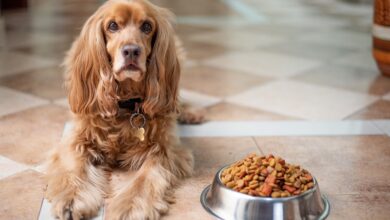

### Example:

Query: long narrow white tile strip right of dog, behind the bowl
xmin=179 ymin=121 xmax=382 ymax=137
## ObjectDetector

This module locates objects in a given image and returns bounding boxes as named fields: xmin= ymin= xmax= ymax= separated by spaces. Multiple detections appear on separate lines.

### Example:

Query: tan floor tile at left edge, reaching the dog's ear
xmin=0 ymin=67 xmax=65 ymax=99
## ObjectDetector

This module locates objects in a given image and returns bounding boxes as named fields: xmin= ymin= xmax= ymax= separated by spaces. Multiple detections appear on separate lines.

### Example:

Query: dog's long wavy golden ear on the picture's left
xmin=65 ymin=3 xmax=117 ymax=116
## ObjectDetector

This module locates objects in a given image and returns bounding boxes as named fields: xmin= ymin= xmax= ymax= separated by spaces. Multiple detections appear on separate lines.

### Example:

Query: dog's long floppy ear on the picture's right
xmin=143 ymin=6 xmax=180 ymax=117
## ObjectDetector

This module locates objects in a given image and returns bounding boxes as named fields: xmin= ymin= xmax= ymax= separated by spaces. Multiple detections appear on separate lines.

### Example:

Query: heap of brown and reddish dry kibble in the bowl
xmin=221 ymin=154 xmax=314 ymax=198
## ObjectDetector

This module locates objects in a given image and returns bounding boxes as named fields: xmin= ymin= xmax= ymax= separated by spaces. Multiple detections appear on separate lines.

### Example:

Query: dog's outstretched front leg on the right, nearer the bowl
xmin=109 ymin=151 xmax=193 ymax=220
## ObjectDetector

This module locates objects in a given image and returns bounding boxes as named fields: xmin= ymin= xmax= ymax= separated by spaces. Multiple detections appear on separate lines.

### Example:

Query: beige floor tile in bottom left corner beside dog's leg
xmin=0 ymin=170 xmax=45 ymax=220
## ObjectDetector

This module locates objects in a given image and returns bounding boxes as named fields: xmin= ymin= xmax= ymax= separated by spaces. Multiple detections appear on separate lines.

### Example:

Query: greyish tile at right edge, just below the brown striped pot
xmin=293 ymin=65 xmax=390 ymax=95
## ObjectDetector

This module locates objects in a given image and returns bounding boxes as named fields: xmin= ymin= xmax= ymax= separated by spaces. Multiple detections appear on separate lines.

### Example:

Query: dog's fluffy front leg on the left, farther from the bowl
xmin=46 ymin=139 xmax=108 ymax=220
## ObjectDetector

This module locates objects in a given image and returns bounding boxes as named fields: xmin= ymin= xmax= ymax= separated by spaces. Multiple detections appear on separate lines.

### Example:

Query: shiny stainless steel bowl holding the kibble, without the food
xmin=200 ymin=166 xmax=330 ymax=220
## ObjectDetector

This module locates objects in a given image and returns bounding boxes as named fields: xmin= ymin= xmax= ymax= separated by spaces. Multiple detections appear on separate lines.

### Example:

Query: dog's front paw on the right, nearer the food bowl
xmin=109 ymin=196 xmax=169 ymax=220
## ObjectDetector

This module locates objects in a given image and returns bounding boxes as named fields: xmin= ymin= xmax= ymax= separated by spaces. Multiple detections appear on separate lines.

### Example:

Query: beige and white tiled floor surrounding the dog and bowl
xmin=0 ymin=0 xmax=390 ymax=220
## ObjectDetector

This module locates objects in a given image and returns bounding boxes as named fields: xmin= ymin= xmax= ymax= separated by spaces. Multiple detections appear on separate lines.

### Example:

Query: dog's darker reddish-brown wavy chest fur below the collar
xmin=86 ymin=114 xmax=176 ymax=169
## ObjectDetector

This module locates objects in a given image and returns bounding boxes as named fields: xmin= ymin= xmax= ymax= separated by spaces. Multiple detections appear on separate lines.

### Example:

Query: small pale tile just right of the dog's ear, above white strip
xmin=180 ymin=89 xmax=221 ymax=108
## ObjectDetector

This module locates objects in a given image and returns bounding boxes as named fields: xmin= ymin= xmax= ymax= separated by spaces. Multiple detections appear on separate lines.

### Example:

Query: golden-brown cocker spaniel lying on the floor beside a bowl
xmin=45 ymin=0 xmax=201 ymax=220
